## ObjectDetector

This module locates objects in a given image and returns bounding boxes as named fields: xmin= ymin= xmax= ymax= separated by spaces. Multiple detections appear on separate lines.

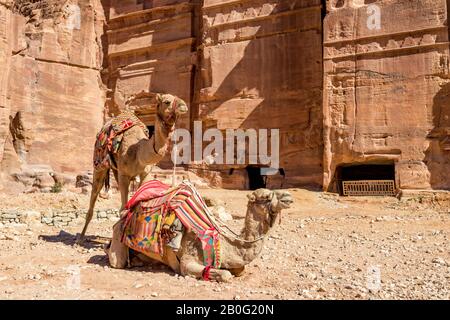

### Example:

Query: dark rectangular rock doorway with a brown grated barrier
xmin=336 ymin=163 xmax=396 ymax=196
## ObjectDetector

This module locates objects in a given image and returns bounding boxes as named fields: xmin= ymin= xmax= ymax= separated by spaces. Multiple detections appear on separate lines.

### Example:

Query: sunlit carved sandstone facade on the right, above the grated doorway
xmin=324 ymin=0 xmax=450 ymax=189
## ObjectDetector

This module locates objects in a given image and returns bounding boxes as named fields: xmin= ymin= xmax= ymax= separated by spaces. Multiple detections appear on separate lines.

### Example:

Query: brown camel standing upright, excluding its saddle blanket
xmin=78 ymin=94 xmax=188 ymax=244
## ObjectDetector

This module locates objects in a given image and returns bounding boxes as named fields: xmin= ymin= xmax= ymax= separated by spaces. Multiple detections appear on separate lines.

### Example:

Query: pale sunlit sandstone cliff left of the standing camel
xmin=0 ymin=0 xmax=105 ymax=192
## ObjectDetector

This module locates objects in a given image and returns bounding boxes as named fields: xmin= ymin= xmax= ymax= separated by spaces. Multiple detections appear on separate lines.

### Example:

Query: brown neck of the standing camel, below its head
xmin=142 ymin=117 xmax=173 ymax=164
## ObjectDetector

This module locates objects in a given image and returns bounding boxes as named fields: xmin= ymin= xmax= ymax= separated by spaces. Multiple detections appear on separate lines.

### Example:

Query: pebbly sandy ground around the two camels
xmin=0 ymin=189 xmax=450 ymax=300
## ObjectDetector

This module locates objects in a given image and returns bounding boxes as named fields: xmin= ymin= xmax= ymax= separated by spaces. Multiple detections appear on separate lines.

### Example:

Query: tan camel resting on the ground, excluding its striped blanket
xmin=105 ymin=189 xmax=293 ymax=282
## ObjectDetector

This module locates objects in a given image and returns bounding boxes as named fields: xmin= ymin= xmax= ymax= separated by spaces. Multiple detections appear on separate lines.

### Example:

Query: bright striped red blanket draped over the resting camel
xmin=122 ymin=181 xmax=220 ymax=268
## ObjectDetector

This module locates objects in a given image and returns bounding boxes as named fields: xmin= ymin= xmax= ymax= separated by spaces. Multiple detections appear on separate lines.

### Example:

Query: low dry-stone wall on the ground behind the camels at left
xmin=0 ymin=209 xmax=119 ymax=227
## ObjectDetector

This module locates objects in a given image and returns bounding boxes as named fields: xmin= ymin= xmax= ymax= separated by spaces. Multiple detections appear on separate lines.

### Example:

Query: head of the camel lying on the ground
xmin=247 ymin=189 xmax=294 ymax=227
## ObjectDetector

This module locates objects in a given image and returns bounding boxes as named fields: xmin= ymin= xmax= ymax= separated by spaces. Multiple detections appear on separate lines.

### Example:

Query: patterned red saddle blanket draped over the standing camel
xmin=94 ymin=110 xmax=148 ymax=169
